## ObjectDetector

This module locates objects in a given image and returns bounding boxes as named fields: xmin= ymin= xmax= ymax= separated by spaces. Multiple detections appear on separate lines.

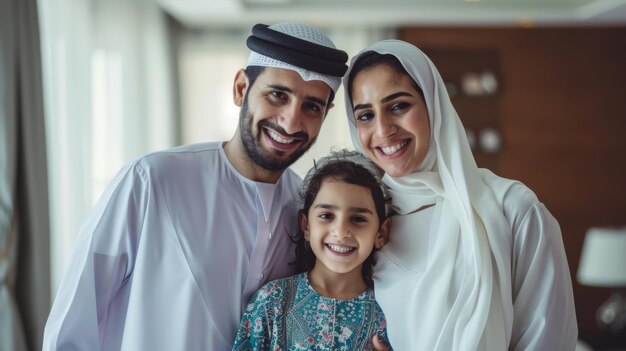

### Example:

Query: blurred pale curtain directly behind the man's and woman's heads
xmin=179 ymin=27 xmax=394 ymax=176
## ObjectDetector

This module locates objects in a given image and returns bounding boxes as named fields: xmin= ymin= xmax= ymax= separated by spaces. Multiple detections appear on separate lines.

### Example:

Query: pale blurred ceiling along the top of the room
xmin=156 ymin=0 xmax=626 ymax=28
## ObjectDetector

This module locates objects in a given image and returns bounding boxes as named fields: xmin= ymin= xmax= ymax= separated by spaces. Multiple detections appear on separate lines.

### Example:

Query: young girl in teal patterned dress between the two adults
xmin=233 ymin=150 xmax=389 ymax=350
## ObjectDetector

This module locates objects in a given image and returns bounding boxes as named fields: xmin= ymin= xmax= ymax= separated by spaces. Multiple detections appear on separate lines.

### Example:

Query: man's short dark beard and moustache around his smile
xmin=239 ymin=96 xmax=317 ymax=171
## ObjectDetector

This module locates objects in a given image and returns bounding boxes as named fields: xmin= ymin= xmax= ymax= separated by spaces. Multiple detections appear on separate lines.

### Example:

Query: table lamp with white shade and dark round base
xmin=576 ymin=227 xmax=626 ymax=335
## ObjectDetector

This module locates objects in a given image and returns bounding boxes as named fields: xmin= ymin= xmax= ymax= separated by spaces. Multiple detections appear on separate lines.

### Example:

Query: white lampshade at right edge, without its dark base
xmin=577 ymin=228 xmax=626 ymax=287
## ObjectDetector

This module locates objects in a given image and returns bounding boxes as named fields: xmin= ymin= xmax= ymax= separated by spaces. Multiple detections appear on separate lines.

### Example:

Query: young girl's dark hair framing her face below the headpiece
xmin=292 ymin=159 xmax=388 ymax=287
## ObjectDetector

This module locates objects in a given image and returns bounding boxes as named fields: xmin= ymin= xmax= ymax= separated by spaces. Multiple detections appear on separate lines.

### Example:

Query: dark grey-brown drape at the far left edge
xmin=0 ymin=0 xmax=50 ymax=351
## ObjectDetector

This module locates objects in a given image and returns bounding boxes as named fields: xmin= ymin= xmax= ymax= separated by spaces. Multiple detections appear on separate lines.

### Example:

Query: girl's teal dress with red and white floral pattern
xmin=233 ymin=273 xmax=388 ymax=351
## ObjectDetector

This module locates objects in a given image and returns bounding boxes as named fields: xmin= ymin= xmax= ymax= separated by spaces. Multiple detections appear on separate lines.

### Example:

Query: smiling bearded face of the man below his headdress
xmin=239 ymin=67 xmax=331 ymax=171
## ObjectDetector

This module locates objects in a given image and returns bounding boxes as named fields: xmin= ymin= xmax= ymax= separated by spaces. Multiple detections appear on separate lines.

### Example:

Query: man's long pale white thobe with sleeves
xmin=43 ymin=142 xmax=300 ymax=351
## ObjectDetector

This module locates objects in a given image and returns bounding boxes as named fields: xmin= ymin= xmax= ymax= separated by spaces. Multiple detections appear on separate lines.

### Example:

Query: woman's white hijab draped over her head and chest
xmin=343 ymin=40 xmax=512 ymax=350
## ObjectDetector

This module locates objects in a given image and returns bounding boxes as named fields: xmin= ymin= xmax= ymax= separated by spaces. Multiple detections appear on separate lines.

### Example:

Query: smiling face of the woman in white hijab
xmin=351 ymin=64 xmax=430 ymax=177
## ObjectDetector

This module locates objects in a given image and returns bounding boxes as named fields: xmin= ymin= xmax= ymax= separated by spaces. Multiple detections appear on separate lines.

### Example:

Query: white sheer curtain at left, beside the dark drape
xmin=39 ymin=0 xmax=178 ymax=295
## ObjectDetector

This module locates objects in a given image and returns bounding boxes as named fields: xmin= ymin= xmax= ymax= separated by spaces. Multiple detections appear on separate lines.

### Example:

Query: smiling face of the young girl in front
xmin=300 ymin=176 xmax=387 ymax=279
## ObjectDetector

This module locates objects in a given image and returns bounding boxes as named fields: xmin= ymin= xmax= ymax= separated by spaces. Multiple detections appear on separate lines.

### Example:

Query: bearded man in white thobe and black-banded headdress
xmin=44 ymin=23 xmax=347 ymax=351
